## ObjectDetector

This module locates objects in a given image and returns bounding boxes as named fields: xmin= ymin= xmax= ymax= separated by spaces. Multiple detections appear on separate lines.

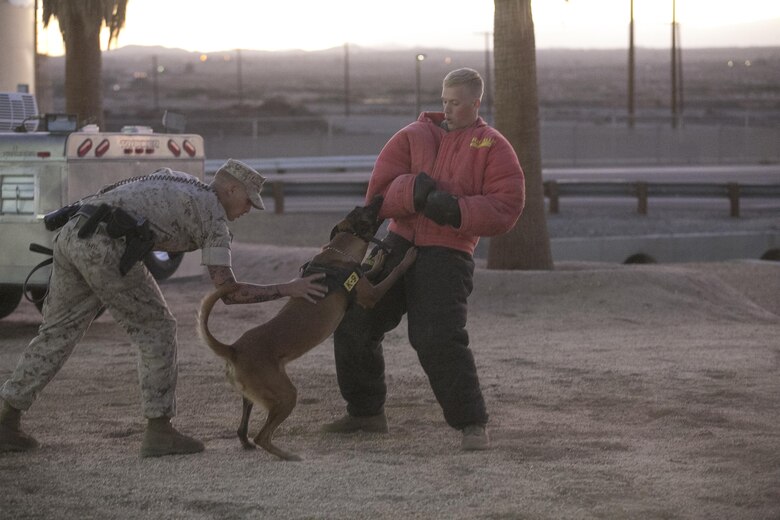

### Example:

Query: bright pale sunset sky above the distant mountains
xmin=39 ymin=0 xmax=780 ymax=55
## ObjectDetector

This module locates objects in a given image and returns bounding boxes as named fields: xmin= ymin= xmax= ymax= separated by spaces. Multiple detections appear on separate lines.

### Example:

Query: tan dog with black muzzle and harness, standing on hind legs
xmin=198 ymin=197 xmax=417 ymax=460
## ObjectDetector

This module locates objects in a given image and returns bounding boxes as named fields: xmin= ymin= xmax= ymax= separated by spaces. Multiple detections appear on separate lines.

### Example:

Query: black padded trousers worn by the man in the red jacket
xmin=334 ymin=233 xmax=488 ymax=429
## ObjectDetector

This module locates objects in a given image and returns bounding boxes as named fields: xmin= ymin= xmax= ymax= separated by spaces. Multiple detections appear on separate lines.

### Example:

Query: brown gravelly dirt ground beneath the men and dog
xmin=0 ymin=210 xmax=780 ymax=519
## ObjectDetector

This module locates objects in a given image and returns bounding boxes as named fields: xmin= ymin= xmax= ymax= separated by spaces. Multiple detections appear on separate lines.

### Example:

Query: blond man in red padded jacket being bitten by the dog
xmin=323 ymin=68 xmax=525 ymax=450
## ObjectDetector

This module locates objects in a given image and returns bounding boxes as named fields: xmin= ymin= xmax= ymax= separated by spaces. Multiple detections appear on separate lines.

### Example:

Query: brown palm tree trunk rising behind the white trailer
xmin=63 ymin=17 xmax=103 ymax=127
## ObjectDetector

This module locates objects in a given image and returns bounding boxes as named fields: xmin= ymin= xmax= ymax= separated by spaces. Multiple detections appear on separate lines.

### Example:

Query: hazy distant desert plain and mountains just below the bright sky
xmin=40 ymin=40 xmax=780 ymax=125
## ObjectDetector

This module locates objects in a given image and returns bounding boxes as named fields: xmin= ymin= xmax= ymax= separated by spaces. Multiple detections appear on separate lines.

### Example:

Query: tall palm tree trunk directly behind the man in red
xmin=487 ymin=0 xmax=553 ymax=270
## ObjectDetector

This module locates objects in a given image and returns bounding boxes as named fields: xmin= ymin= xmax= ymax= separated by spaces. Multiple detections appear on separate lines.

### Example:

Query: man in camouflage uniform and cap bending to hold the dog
xmin=0 ymin=159 xmax=326 ymax=457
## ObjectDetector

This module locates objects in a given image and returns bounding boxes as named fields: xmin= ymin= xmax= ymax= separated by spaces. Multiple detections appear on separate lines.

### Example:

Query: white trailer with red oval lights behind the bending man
xmin=0 ymin=107 xmax=205 ymax=318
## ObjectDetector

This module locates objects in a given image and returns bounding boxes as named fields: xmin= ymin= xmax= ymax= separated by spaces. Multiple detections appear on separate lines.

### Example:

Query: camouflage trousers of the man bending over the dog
xmin=0 ymin=218 xmax=177 ymax=418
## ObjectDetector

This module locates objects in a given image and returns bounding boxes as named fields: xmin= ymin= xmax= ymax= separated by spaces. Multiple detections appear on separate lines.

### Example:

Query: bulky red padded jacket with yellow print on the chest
xmin=366 ymin=112 xmax=525 ymax=254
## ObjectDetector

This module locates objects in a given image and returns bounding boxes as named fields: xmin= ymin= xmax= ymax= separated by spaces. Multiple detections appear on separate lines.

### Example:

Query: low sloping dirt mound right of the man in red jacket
xmin=472 ymin=262 xmax=780 ymax=324
